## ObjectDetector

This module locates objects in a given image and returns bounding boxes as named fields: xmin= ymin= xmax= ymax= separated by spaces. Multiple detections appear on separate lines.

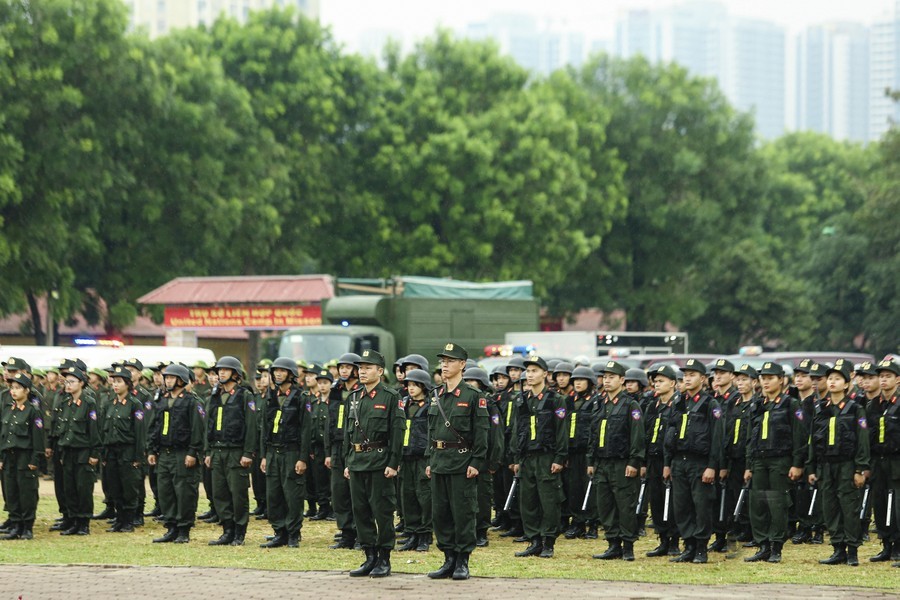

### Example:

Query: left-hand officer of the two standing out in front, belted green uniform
xmin=343 ymin=350 xmax=406 ymax=577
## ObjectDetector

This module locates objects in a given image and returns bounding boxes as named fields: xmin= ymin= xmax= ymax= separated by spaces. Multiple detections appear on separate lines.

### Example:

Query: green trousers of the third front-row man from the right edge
xmin=750 ymin=456 xmax=794 ymax=544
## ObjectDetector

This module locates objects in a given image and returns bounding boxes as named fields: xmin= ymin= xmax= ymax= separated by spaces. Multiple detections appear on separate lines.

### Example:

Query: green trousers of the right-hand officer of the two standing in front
xmin=431 ymin=473 xmax=478 ymax=552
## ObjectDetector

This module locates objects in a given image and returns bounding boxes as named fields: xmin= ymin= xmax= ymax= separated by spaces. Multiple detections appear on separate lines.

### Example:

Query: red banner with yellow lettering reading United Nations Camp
xmin=164 ymin=306 xmax=322 ymax=329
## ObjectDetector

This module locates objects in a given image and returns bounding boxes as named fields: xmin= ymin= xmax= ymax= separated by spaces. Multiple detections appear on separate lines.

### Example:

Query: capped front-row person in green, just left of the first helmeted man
xmin=102 ymin=365 xmax=147 ymax=533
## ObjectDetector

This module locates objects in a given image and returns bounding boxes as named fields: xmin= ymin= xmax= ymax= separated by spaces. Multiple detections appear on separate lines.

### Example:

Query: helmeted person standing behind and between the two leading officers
xmin=398 ymin=368 xmax=432 ymax=552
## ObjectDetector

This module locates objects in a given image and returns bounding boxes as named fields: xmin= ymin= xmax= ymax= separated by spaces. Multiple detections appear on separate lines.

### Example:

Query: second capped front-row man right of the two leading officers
xmin=588 ymin=360 xmax=646 ymax=561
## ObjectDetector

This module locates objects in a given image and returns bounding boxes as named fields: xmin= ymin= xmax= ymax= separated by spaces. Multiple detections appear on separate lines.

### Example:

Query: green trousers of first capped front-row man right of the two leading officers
xmin=518 ymin=453 xmax=563 ymax=539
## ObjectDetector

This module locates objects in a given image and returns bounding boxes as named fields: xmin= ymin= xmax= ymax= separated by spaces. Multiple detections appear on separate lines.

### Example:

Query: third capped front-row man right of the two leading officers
xmin=663 ymin=358 xmax=724 ymax=564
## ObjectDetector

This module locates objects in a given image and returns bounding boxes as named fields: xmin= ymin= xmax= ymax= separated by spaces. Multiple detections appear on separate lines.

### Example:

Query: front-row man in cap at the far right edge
xmin=860 ymin=360 xmax=900 ymax=566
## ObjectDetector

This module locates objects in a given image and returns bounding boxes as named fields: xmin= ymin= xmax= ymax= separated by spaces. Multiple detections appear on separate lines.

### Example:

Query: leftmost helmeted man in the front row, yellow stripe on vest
xmin=147 ymin=364 xmax=206 ymax=544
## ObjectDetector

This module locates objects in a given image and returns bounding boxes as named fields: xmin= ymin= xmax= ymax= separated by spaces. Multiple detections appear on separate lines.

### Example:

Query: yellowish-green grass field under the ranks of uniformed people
xmin=0 ymin=482 xmax=900 ymax=589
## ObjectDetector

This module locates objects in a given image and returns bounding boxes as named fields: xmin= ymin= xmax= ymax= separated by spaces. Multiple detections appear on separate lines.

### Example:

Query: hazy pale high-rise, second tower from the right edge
xmin=796 ymin=23 xmax=870 ymax=142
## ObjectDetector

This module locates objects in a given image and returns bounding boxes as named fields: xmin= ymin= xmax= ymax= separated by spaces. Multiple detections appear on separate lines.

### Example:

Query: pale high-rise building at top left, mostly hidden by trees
xmin=125 ymin=0 xmax=319 ymax=37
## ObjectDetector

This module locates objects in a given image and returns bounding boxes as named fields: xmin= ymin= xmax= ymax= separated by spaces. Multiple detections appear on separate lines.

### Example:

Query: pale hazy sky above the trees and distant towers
xmin=320 ymin=0 xmax=895 ymax=48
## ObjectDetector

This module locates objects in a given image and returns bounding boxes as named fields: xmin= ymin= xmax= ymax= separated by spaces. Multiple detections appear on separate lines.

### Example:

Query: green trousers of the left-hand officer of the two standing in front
xmin=350 ymin=470 xmax=397 ymax=550
